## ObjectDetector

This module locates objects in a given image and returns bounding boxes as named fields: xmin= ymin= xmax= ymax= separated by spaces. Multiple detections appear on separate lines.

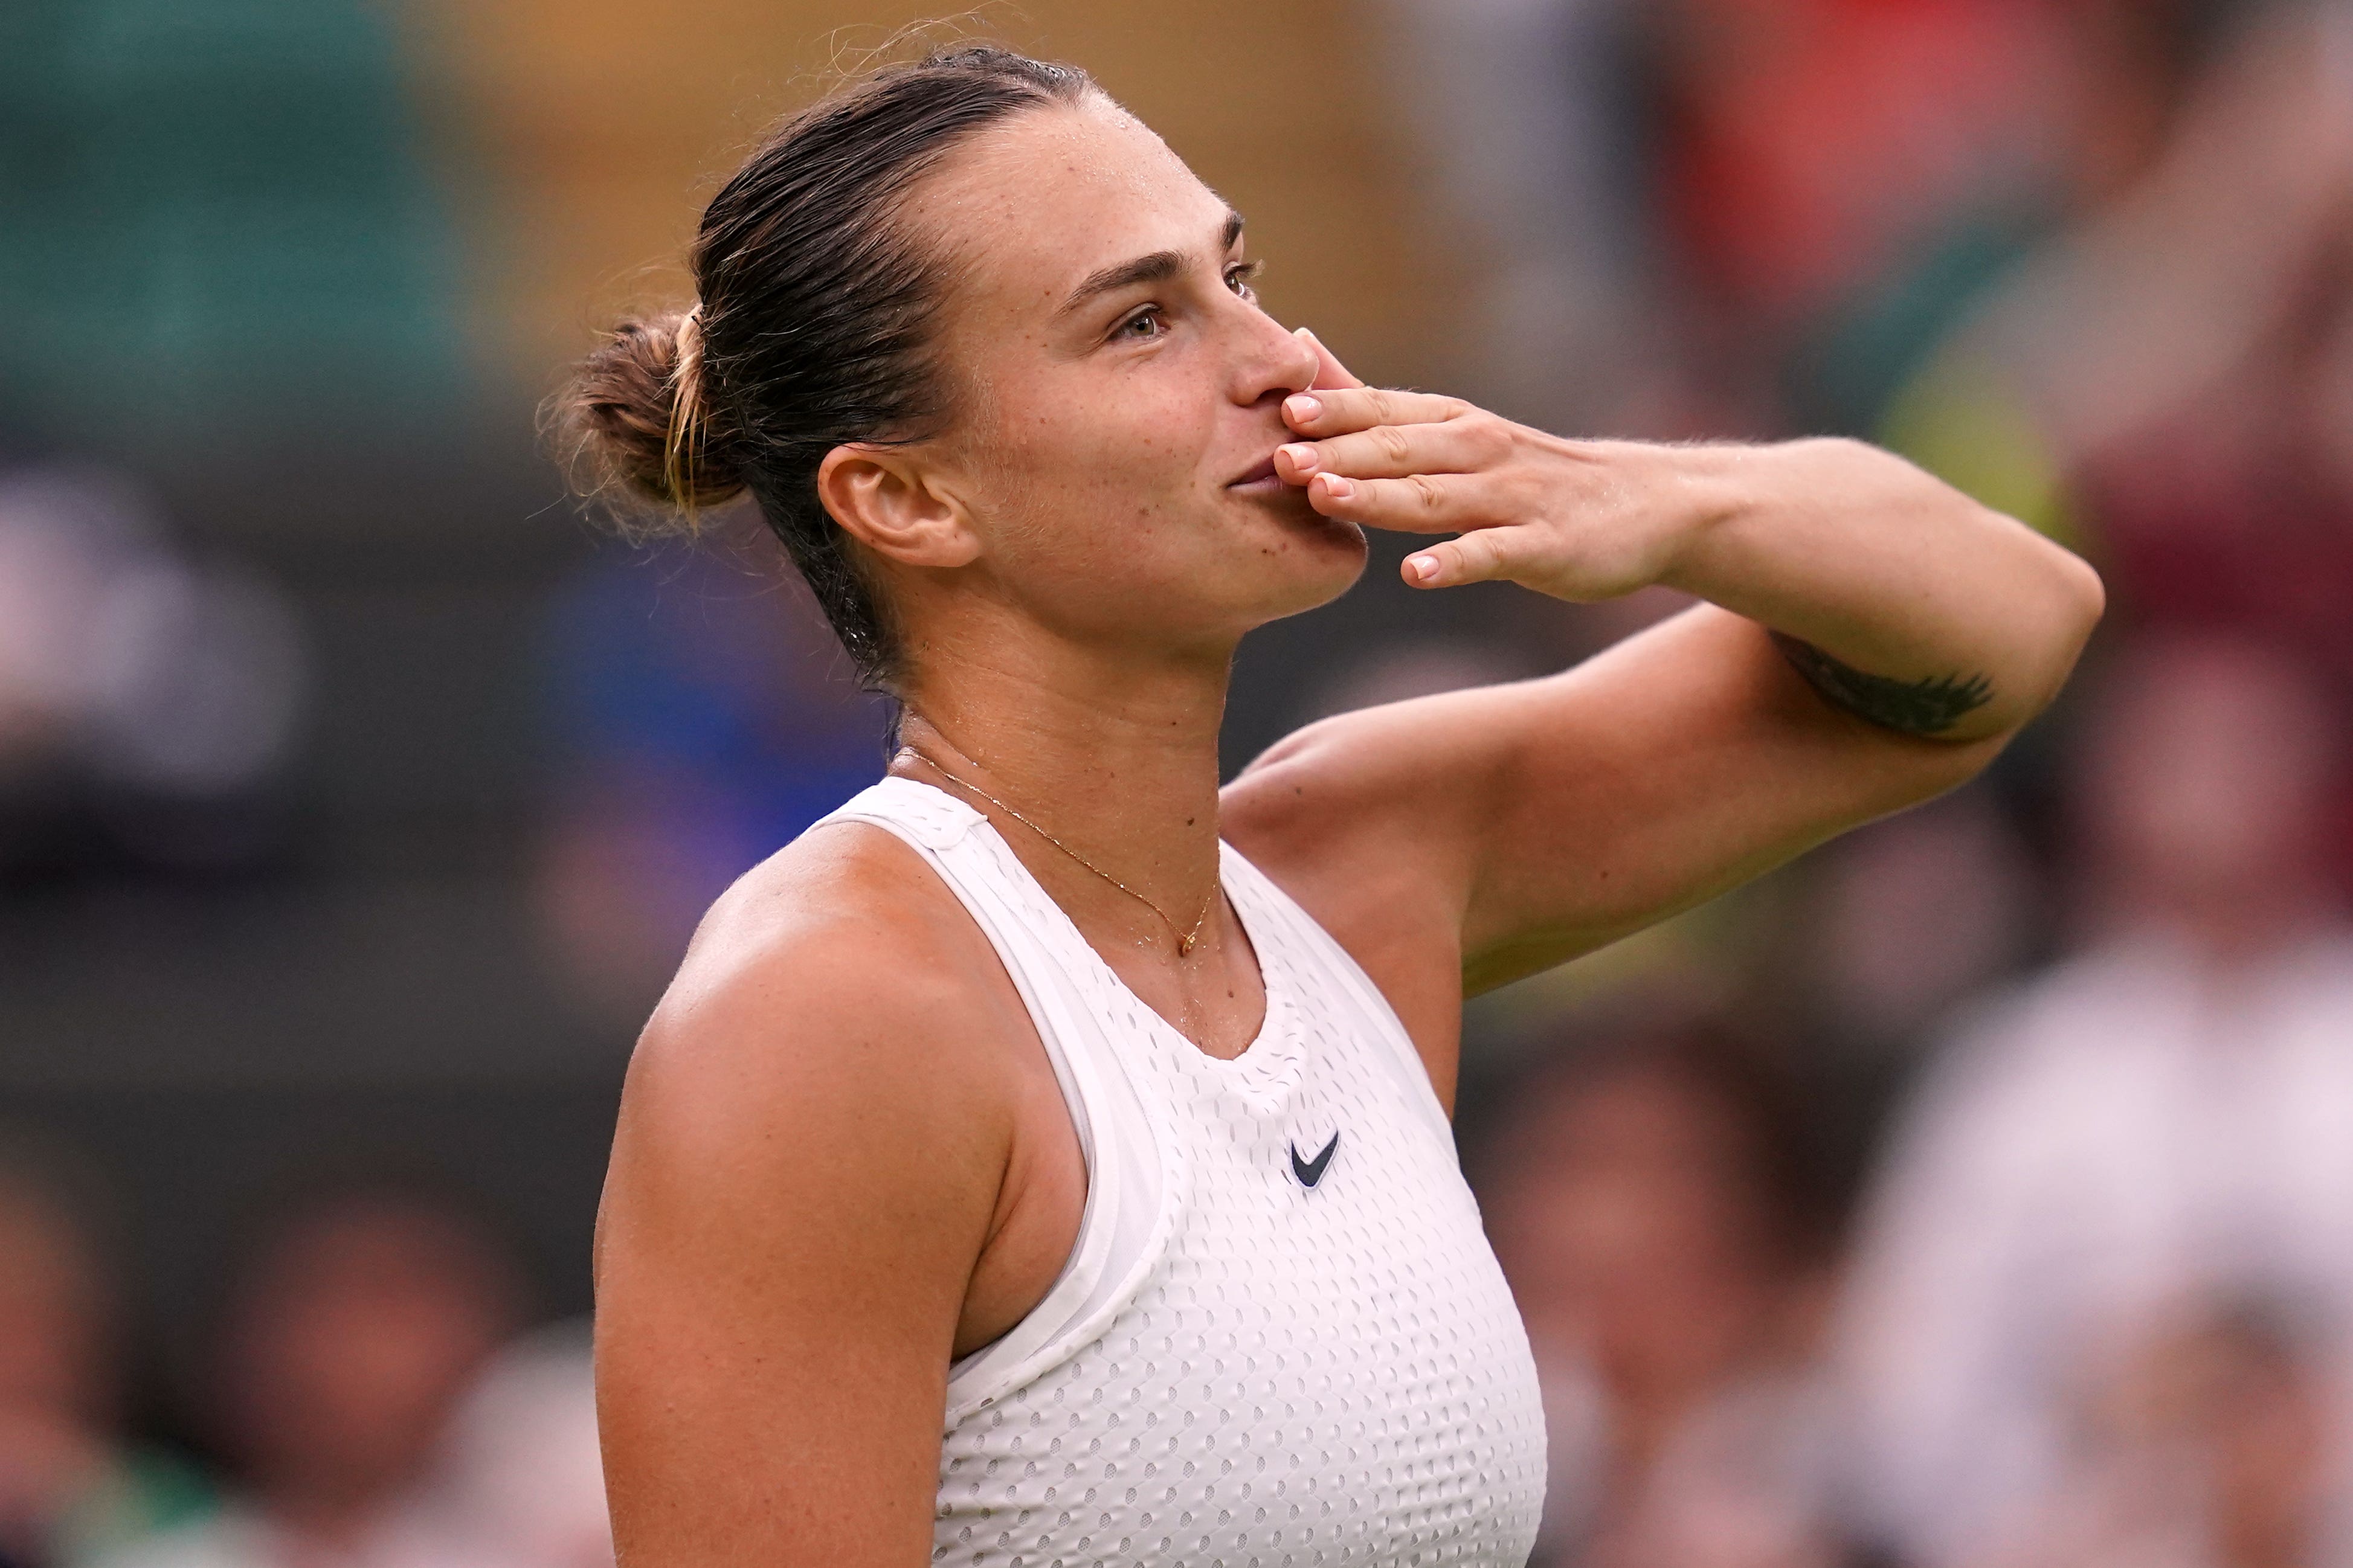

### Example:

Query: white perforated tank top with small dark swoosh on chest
xmin=826 ymin=777 xmax=1543 ymax=1568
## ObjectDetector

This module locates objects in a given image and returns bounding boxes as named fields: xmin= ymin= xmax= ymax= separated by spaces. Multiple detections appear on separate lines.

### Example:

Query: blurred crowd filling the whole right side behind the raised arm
xmin=1400 ymin=0 xmax=2353 ymax=1568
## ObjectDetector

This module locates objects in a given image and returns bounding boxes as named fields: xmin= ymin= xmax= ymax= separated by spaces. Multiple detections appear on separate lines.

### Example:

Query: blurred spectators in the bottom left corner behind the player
xmin=0 ymin=1140 xmax=612 ymax=1568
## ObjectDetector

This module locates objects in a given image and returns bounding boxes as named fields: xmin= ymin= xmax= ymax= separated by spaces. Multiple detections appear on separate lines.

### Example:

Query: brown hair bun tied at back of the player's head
xmin=555 ymin=311 xmax=744 ymax=516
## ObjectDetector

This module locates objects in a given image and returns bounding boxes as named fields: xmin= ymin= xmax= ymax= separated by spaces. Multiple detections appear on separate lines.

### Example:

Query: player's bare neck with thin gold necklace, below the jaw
xmin=892 ymin=622 xmax=1231 ymax=944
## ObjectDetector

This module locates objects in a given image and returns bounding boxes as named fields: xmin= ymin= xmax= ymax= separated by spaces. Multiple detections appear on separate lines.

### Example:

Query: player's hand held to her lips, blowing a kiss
xmin=1275 ymin=344 xmax=1708 ymax=603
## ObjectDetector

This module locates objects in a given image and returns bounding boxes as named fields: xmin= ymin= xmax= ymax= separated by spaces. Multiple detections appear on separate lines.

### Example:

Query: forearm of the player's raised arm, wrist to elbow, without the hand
xmin=1661 ymin=440 xmax=2101 ymax=742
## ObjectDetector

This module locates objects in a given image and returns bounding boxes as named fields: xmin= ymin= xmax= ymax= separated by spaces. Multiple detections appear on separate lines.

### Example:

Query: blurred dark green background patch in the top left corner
xmin=0 ymin=0 xmax=471 ymax=461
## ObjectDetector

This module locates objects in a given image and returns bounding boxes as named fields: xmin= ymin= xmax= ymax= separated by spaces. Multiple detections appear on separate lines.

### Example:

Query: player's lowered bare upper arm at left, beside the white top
xmin=597 ymin=930 xmax=1009 ymax=1568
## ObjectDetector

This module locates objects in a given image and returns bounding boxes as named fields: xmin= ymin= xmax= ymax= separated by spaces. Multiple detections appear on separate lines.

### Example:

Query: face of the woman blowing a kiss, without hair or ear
xmin=908 ymin=97 xmax=1365 ymax=652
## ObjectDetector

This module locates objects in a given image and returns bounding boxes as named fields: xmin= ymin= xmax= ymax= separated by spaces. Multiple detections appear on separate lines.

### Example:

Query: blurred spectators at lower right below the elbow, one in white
xmin=1473 ymin=617 xmax=2353 ymax=1568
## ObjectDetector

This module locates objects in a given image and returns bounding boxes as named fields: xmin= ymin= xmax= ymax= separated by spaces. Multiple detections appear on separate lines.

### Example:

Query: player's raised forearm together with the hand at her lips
xmin=1275 ymin=384 xmax=2101 ymax=742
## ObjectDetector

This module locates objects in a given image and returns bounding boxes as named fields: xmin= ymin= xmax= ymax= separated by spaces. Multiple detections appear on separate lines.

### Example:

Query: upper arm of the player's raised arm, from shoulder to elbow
xmin=1228 ymin=605 xmax=1998 ymax=1003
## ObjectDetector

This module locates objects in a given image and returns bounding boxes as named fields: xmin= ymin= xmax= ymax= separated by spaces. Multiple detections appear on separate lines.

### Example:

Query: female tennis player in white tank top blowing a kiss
xmin=567 ymin=45 xmax=2101 ymax=1568
